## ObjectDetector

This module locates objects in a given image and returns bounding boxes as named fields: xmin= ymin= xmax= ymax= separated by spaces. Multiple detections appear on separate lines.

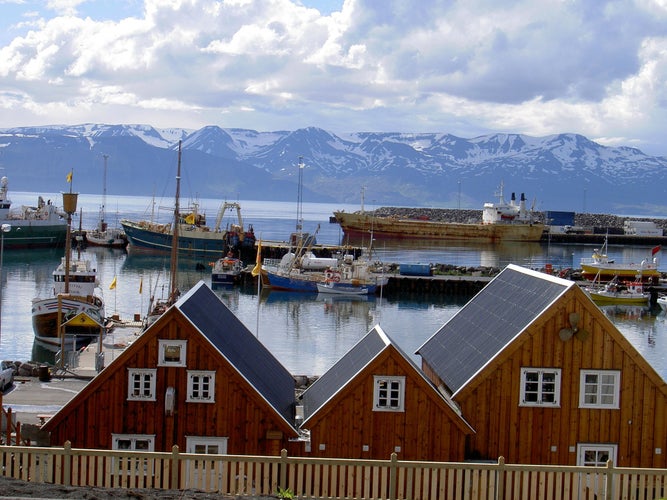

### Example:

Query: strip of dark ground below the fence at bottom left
xmin=0 ymin=477 xmax=272 ymax=500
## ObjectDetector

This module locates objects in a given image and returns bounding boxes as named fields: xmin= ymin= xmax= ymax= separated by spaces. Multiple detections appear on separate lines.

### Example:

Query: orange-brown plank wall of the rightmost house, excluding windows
xmin=422 ymin=287 xmax=667 ymax=468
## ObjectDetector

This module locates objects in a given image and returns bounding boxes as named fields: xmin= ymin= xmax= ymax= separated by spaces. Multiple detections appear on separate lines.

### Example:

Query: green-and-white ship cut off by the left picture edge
xmin=0 ymin=176 xmax=67 ymax=248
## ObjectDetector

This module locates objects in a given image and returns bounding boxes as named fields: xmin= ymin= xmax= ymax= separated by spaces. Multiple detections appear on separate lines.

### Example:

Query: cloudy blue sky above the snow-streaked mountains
xmin=0 ymin=0 xmax=667 ymax=156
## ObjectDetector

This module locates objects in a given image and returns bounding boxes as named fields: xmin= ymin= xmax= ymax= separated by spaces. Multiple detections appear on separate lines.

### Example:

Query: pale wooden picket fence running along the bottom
xmin=0 ymin=444 xmax=667 ymax=500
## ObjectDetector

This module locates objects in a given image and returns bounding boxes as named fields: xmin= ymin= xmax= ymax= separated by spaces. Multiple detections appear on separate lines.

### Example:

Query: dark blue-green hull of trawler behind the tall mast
xmin=121 ymin=220 xmax=255 ymax=258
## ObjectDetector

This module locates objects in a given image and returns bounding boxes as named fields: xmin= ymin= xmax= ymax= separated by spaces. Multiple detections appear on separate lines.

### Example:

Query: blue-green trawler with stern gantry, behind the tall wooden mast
xmin=120 ymin=195 xmax=255 ymax=258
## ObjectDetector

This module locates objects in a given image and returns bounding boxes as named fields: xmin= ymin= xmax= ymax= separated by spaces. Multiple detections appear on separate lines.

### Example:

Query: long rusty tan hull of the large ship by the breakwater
xmin=334 ymin=212 xmax=545 ymax=243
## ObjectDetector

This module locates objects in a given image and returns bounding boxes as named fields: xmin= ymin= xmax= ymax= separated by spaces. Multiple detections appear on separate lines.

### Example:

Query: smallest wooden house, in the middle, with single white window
xmin=300 ymin=326 xmax=472 ymax=461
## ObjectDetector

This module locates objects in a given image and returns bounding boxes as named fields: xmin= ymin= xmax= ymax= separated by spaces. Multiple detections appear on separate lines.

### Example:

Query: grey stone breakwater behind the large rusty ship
xmin=368 ymin=207 xmax=667 ymax=231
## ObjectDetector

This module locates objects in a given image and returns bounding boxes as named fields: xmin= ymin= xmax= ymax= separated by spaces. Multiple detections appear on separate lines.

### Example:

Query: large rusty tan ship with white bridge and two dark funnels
xmin=334 ymin=184 xmax=545 ymax=243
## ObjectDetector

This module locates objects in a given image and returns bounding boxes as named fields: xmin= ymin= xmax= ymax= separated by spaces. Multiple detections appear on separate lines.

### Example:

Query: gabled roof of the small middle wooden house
xmin=301 ymin=325 xmax=472 ymax=431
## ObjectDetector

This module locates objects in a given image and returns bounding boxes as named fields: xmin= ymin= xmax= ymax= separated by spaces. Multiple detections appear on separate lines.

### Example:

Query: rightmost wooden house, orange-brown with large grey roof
xmin=417 ymin=265 xmax=667 ymax=468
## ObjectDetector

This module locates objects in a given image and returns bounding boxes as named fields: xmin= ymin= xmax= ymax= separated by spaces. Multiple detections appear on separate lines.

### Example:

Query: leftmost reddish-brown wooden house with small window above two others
xmin=44 ymin=282 xmax=298 ymax=455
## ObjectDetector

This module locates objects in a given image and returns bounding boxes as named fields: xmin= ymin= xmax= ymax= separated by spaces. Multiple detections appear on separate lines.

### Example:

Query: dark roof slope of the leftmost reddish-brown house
xmin=175 ymin=281 xmax=295 ymax=425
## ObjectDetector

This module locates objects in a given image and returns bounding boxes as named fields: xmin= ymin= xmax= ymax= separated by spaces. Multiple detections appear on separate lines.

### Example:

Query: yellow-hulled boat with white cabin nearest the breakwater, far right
xmin=580 ymin=237 xmax=662 ymax=281
